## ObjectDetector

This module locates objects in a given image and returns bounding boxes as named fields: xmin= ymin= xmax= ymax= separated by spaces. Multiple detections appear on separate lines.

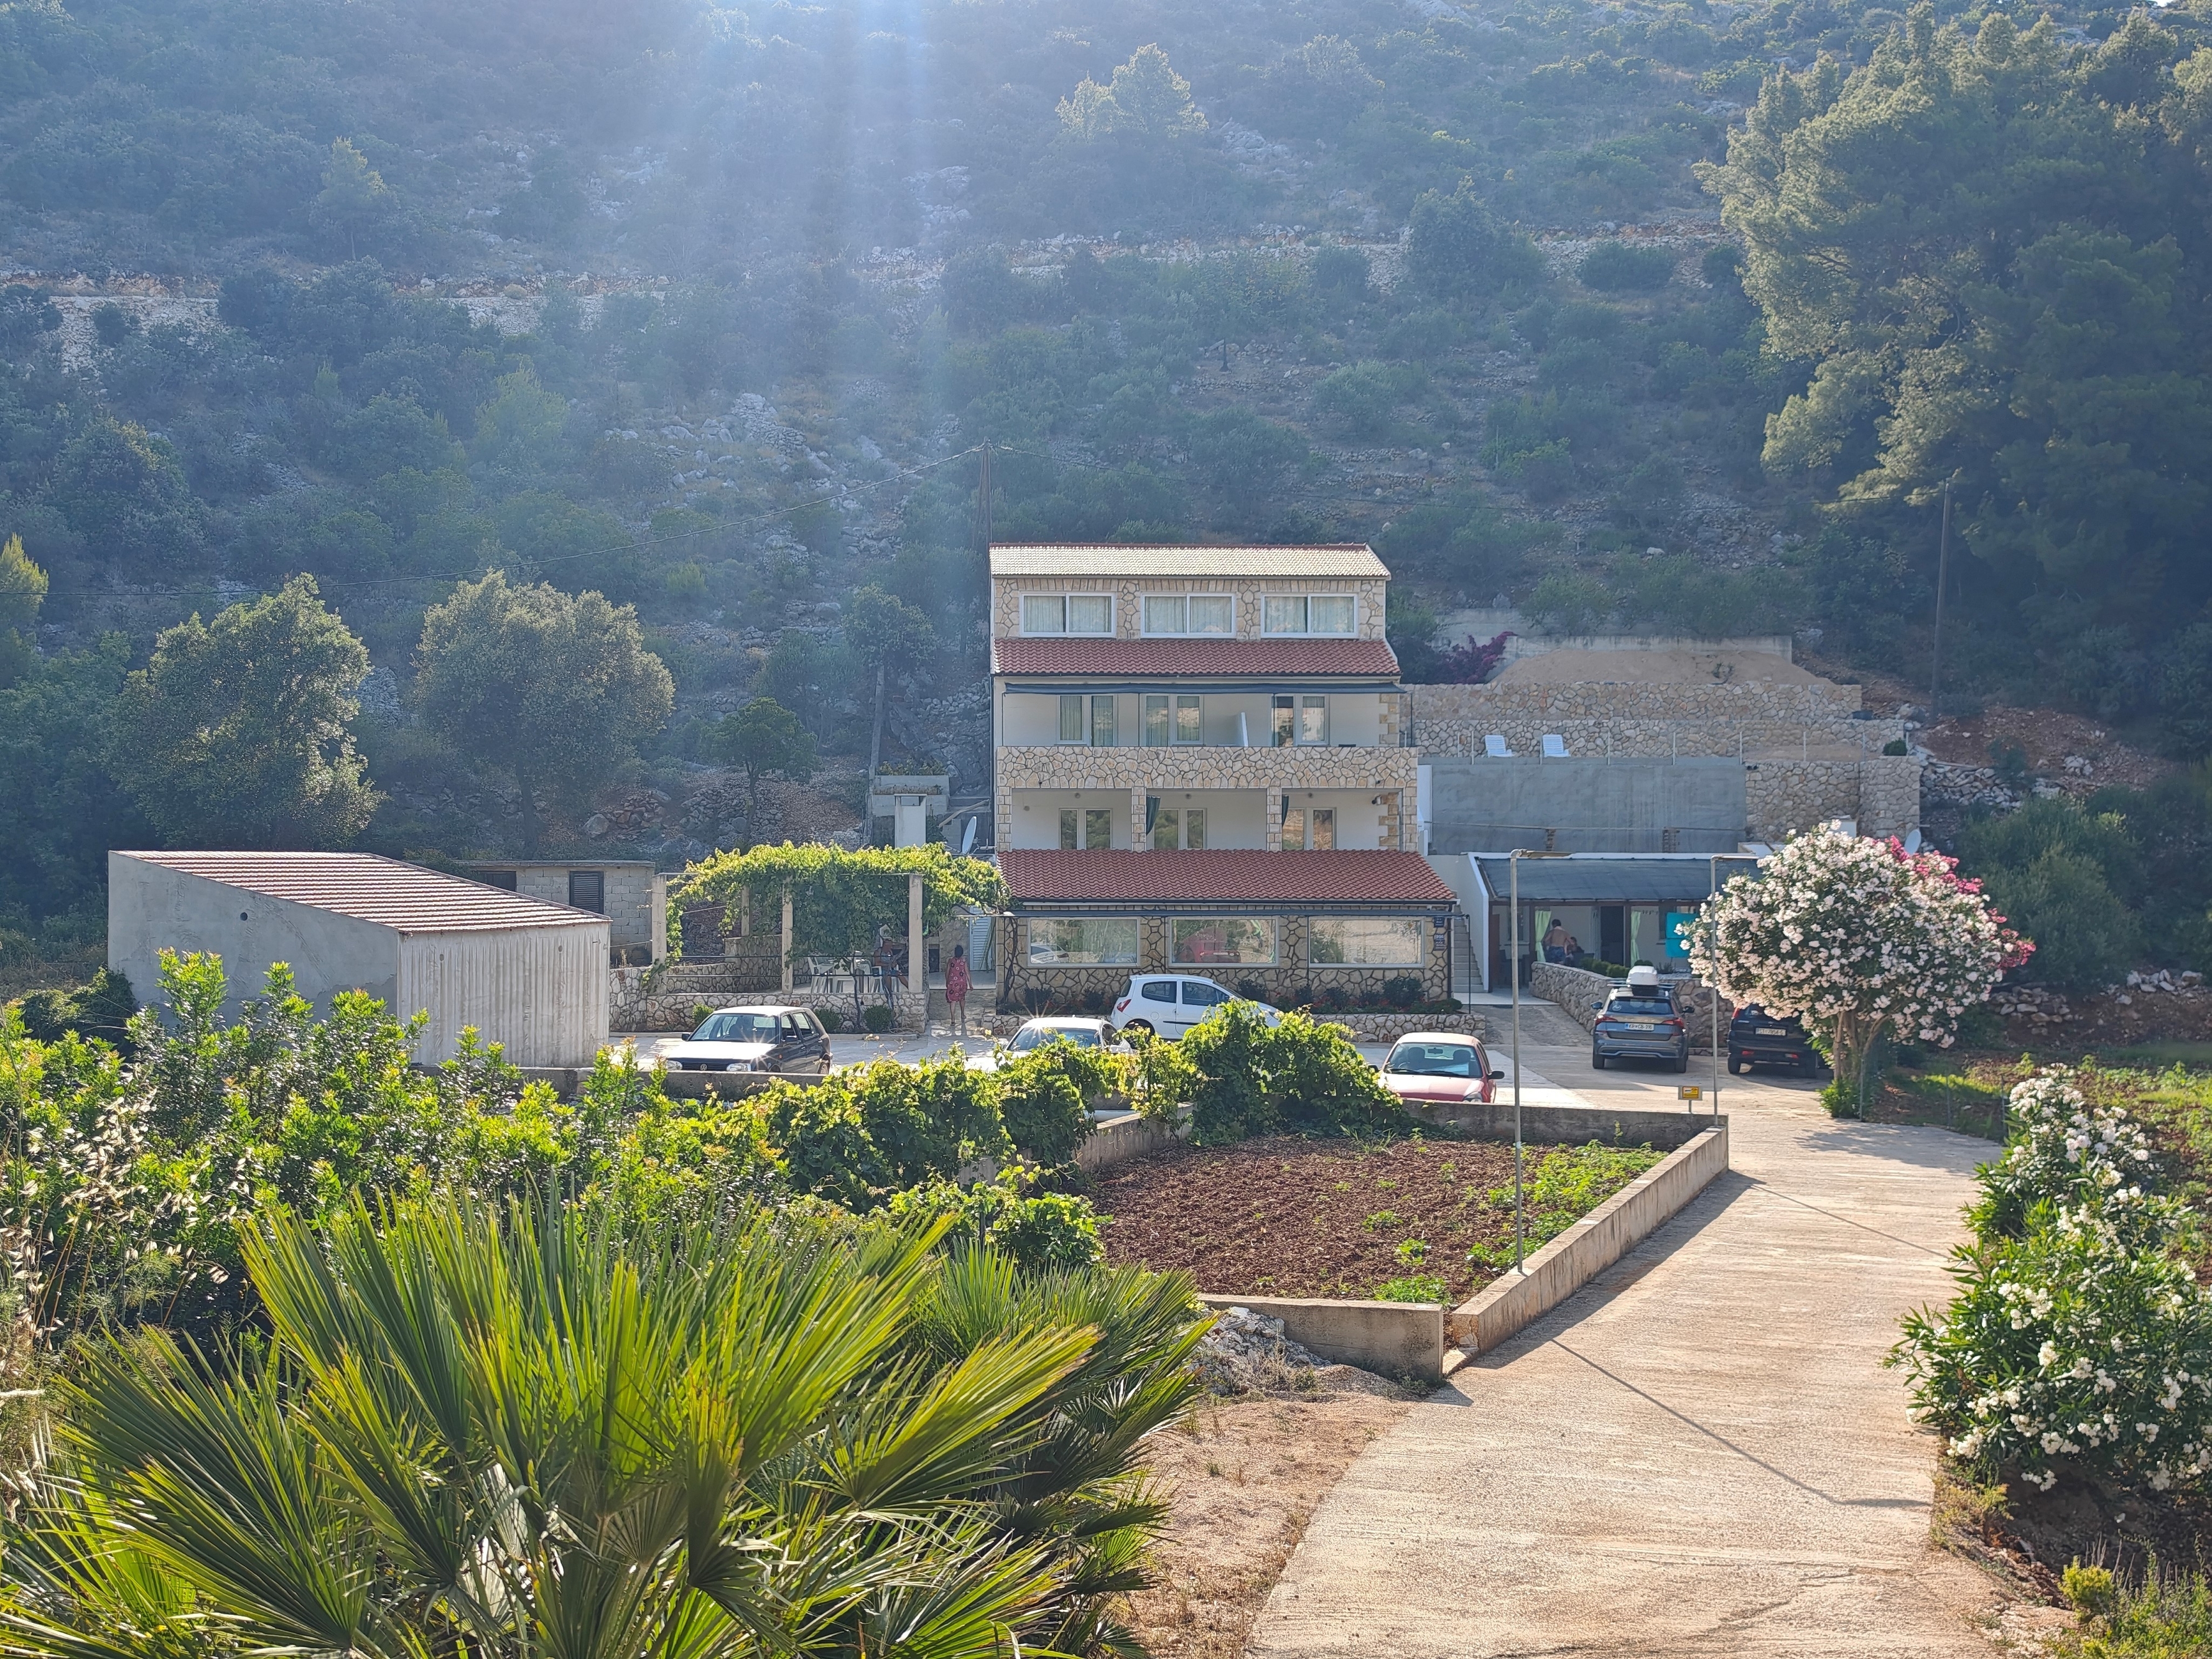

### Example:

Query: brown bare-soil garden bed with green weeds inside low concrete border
xmin=1095 ymin=1135 xmax=1661 ymax=1303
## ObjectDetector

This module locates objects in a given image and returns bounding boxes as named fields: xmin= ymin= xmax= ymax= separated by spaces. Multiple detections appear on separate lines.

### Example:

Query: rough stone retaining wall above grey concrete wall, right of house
xmin=1407 ymin=681 xmax=1905 ymax=759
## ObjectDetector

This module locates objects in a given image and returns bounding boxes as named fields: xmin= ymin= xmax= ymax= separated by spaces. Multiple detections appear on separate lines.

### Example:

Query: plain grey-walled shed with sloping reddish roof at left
xmin=108 ymin=852 xmax=608 ymax=1066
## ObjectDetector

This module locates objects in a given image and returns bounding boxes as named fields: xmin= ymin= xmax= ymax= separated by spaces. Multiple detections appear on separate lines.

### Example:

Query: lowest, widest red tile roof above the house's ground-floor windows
xmin=998 ymin=847 xmax=1456 ymax=904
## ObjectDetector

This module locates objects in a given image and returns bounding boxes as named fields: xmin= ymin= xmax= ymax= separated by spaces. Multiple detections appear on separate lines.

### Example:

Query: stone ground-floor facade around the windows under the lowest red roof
xmin=998 ymin=904 xmax=1451 ymax=1013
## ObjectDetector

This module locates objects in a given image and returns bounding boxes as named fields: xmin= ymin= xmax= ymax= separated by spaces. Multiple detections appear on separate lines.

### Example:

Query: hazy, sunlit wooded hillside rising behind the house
xmin=0 ymin=0 xmax=2212 ymax=974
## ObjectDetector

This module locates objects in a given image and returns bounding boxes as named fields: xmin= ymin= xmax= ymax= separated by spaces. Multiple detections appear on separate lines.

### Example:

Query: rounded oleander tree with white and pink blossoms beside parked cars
xmin=1690 ymin=827 xmax=2035 ymax=1097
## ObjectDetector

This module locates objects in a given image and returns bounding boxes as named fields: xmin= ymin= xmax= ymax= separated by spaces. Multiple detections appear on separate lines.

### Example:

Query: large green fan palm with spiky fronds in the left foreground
xmin=0 ymin=1197 xmax=1197 ymax=1659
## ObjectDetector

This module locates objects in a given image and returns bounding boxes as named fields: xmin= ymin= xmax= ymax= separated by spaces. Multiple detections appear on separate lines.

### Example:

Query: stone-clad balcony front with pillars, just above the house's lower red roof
xmin=995 ymin=743 xmax=1415 ymax=852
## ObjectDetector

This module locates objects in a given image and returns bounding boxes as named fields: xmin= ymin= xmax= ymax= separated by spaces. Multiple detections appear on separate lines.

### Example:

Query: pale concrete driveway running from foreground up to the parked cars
xmin=1248 ymin=1004 xmax=1991 ymax=1659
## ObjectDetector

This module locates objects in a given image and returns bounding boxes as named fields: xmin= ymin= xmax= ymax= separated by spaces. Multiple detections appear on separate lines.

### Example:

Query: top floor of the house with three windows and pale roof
xmin=991 ymin=542 xmax=1389 ymax=639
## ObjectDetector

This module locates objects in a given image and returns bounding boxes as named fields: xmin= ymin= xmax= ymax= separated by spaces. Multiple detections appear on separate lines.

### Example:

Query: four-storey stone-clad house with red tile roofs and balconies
xmin=991 ymin=546 xmax=1453 ymax=1006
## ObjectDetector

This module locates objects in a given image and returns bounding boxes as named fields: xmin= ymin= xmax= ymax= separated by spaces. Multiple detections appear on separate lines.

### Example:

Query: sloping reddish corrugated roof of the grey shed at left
xmin=117 ymin=852 xmax=606 ymax=934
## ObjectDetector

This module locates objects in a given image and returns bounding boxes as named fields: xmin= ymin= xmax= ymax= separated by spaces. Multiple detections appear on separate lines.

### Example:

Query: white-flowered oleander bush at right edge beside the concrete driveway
xmin=1891 ymin=1071 xmax=2212 ymax=1491
